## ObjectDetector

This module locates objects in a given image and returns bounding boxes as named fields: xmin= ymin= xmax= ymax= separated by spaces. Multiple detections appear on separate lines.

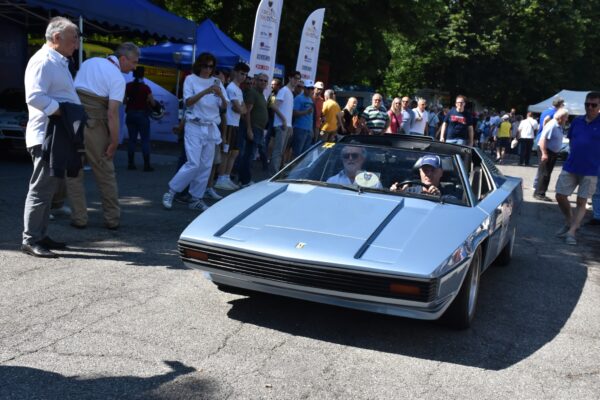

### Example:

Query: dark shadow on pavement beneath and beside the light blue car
xmin=223 ymin=198 xmax=587 ymax=370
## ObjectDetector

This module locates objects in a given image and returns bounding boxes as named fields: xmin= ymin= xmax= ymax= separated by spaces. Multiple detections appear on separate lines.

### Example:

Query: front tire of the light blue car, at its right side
xmin=440 ymin=248 xmax=481 ymax=329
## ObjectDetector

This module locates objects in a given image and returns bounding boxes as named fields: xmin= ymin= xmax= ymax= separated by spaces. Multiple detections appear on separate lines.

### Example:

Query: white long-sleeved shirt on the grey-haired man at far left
xmin=25 ymin=44 xmax=81 ymax=147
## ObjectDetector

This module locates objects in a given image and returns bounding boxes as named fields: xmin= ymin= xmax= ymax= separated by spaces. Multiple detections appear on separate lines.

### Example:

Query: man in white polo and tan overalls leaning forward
xmin=67 ymin=43 xmax=140 ymax=229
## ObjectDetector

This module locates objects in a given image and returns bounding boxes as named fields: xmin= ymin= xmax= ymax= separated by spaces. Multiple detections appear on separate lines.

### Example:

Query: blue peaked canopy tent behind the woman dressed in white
xmin=140 ymin=19 xmax=284 ymax=77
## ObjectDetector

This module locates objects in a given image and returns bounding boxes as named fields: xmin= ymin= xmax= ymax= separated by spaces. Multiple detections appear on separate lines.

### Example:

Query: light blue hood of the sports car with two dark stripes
xmin=181 ymin=183 xmax=486 ymax=277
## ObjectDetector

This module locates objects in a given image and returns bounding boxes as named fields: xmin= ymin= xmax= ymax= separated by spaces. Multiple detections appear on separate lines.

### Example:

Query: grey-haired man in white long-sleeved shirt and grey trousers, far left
xmin=21 ymin=17 xmax=80 ymax=257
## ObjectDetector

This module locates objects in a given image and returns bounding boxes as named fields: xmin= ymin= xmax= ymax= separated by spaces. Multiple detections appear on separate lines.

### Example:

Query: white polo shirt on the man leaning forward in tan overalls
xmin=75 ymin=56 xmax=125 ymax=103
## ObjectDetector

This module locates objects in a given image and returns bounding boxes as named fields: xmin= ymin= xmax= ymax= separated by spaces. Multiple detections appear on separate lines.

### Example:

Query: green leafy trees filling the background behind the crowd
xmin=154 ymin=0 xmax=600 ymax=108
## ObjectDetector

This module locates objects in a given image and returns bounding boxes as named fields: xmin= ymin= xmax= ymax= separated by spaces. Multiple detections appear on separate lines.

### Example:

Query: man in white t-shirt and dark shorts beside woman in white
xmin=215 ymin=62 xmax=250 ymax=190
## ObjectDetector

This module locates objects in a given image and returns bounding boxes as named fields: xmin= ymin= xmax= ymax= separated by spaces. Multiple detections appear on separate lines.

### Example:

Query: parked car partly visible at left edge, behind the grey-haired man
xmin=0 ymin=89 xmax=28 ymax=151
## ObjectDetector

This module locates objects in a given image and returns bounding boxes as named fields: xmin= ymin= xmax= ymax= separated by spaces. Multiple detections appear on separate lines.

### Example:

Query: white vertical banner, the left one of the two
xmin=250 ymin=0 xmax=283 ymax=96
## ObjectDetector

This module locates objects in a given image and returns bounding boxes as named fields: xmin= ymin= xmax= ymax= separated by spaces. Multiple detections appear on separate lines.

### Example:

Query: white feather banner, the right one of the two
xmin=296 ymin=8 xmax=325 ymax=81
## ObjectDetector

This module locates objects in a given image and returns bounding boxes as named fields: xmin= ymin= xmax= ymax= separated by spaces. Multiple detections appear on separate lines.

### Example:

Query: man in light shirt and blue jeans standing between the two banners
xmin=269 ymin=71 xmax=301 ymax=175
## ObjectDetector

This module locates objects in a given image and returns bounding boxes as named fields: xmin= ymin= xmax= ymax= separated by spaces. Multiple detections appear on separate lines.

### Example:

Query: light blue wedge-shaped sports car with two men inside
xmin=179 ymin=135 xmax=523 ymax=329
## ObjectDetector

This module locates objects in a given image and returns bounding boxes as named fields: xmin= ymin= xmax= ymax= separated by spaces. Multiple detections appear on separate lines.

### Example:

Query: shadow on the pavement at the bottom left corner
xmin=0 ymin=361 xmax=216 ymax=400
